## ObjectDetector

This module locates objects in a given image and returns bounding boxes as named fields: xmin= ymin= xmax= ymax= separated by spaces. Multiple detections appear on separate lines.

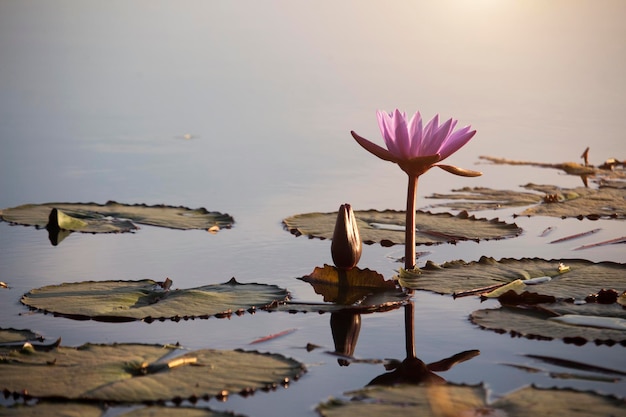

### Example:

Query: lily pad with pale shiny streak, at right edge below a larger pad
xmin=470 ymin=302 xmax=626 ymax=346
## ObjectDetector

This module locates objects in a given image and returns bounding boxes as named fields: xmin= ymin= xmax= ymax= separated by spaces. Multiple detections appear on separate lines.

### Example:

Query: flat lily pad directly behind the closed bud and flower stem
xmin=283 ymin=210 xmax=522 ymax=246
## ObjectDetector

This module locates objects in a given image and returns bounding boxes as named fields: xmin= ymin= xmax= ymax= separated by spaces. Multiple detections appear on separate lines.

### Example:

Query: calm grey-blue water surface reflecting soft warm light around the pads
xmin=0 ymin=0 xmax=626 ymax=416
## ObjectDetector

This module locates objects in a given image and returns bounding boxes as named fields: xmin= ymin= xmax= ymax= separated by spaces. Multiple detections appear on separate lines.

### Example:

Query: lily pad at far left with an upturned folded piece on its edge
xmin=0 ymin=201 xmax=234 ymax=233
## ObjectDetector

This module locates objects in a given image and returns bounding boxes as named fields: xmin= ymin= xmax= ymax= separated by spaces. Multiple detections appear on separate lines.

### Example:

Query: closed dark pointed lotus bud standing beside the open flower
xmin=330 ymin=204 xmax=362 ymax=270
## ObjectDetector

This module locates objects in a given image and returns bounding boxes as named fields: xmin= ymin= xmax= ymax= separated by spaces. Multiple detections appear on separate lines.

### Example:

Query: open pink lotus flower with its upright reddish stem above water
xmin=350 ymin=109 xmax=482 ymax=269
